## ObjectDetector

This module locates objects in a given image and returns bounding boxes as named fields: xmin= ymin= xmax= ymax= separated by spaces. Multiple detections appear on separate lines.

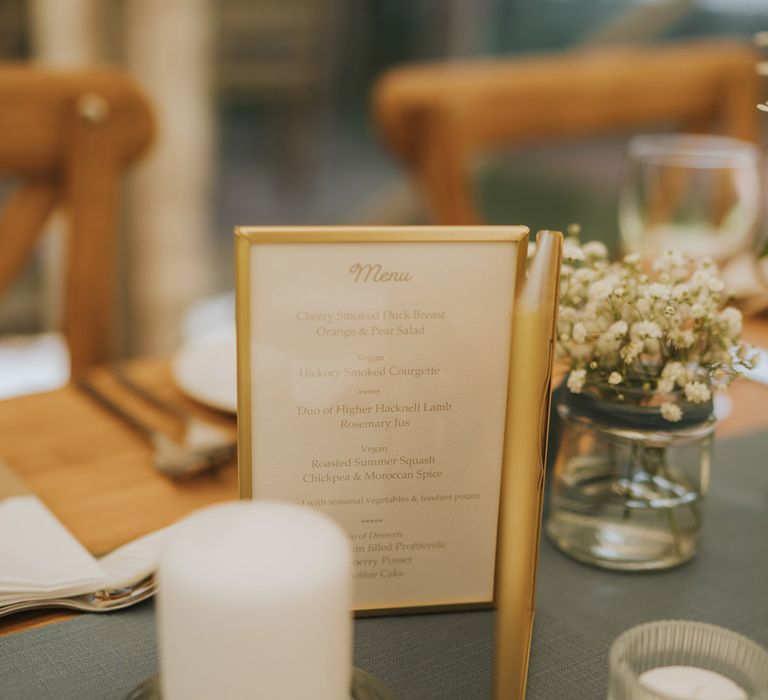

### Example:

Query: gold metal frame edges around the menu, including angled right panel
xmin=235 ymin=226 xmax=562 ymax=697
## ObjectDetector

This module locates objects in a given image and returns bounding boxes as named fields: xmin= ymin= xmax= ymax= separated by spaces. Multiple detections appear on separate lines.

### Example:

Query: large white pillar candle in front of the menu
xmin=158 ymin=501 xmax=352 ymax=700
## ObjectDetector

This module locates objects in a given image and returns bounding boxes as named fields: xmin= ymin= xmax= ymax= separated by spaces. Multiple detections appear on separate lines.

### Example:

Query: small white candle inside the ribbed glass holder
xmin=638 ymin=666 xmax=747 ymax=700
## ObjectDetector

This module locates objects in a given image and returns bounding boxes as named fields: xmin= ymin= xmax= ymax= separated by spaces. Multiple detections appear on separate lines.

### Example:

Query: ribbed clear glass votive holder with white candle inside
xmin=608 ymin=620 xmax=768 ymax=700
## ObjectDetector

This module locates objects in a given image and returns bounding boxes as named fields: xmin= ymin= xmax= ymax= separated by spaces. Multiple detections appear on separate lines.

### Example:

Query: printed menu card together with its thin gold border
xmin=236 ymin=226 xmax=551 ymax=620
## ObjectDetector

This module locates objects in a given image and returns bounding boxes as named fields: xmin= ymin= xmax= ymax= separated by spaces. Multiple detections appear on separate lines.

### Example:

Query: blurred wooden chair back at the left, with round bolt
xmin=0 ymin=65 xmax=153 ymax=373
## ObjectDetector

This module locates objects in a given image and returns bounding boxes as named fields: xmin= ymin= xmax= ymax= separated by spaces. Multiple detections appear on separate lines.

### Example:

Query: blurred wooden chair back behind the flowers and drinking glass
xmin=373 ymin=41 xmax=759 ymax=224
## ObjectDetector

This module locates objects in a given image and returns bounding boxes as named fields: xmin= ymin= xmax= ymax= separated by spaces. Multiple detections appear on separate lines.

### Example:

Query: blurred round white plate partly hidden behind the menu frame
xmin=171 ymin=330 xmax=237 ymax=413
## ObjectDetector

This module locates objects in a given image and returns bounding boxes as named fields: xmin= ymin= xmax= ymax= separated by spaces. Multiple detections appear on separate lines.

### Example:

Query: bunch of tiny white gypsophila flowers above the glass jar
xmin=557 ymin=235 xmax=754 ymax=422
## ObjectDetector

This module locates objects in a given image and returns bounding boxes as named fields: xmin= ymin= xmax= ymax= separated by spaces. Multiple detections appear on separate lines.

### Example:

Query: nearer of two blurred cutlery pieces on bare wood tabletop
xmin=77 ymin=379 xmax=236 ymax=479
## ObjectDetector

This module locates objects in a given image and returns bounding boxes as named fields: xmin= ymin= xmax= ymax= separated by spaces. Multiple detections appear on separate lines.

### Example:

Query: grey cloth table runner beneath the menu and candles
xmin=0 ymin=434 xmax=768 ymax=700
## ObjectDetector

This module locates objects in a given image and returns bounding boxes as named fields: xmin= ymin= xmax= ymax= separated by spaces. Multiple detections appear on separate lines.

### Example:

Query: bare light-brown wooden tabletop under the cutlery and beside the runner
xmin=0 ymin=321 xmax=768 ymax=680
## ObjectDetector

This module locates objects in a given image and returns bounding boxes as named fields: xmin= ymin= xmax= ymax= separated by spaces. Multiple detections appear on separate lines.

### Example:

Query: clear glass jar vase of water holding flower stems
xmin=546 ymin=394 xmax=715 ymax=571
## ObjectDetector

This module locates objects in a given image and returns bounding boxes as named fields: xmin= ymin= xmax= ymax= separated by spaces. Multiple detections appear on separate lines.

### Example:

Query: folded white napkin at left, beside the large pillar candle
xmin=0 ymin=462 xmax=168 ymax=606
